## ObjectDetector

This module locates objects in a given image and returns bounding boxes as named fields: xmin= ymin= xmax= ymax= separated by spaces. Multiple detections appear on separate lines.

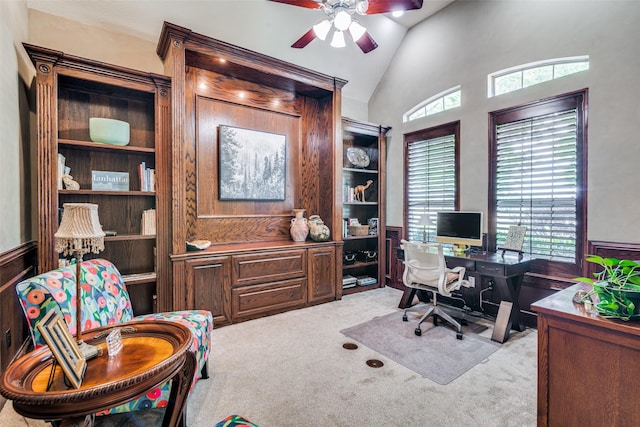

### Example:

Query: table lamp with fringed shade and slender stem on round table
xmin=54 ymin=203 xmax=104 ymax=358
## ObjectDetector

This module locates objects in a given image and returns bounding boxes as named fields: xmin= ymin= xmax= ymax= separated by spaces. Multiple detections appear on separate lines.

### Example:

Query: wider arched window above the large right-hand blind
xmin=488 ymin=55 xmax=589 ymax=98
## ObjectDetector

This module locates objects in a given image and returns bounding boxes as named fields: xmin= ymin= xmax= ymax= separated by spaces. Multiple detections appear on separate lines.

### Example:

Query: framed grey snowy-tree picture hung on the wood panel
xmin=218 ymin=125 xmax=287 ymax=201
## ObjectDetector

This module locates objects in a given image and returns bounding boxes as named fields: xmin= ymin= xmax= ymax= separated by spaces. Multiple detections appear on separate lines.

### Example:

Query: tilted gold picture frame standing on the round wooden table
xmin=37 ymin=310 xmax=87 ymax=388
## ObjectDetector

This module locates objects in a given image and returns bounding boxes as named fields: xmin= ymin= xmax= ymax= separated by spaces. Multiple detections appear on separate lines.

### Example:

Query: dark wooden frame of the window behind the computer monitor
xmin=402 ymin=120 xmax=460 ymax=239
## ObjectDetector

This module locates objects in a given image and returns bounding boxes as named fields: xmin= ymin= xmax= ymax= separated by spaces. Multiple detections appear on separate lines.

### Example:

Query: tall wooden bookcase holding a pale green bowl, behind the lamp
xmin=24 ymin=44 xmax=172 ymax=314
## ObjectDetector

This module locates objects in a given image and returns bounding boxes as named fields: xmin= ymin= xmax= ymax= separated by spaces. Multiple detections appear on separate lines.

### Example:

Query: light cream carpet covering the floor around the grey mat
xmin=0 ymin=288 xmax=537 ymax=427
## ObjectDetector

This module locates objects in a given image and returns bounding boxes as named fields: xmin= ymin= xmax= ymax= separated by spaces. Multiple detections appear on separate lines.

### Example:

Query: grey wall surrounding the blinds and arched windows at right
xmin=369 ymin=0 xmax=640 ymax=243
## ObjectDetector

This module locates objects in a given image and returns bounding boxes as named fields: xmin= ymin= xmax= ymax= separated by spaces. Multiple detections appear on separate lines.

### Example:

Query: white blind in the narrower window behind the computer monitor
xmin=406 ymin=134 xmax=456 ymax=242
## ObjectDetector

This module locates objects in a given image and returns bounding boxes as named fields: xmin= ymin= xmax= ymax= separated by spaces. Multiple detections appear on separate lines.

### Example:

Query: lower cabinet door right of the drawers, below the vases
xmin=307 ymin=247 xmax=342 ymax=304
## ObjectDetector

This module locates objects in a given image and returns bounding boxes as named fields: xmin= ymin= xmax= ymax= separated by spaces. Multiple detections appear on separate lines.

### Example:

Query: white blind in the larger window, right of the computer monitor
xmin=496 ymin=109 xmax=578 ymax=263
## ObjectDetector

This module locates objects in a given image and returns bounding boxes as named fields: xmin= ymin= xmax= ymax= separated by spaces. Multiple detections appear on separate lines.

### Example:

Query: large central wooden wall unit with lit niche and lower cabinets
xmin=157 ymin=22 xmax=346 ymax=326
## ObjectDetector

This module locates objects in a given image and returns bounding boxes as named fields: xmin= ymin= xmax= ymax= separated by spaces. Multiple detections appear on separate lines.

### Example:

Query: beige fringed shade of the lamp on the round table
xmin=54 ymin=203 xmax=104 ymax=256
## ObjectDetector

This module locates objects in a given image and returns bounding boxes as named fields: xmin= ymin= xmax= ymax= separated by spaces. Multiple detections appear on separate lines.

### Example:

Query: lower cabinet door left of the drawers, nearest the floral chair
xmin=185 ymin=256 xmax=231 ymax=325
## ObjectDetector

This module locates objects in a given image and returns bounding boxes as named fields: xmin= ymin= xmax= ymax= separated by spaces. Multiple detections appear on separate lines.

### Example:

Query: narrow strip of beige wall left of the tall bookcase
xmin=0 ymin=0 xmax=35 ymax=253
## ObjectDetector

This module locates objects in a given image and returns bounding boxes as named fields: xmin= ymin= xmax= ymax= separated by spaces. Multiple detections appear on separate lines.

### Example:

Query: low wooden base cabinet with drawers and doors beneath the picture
xmin=172 ymin=242 xmax=337 ymax=325
